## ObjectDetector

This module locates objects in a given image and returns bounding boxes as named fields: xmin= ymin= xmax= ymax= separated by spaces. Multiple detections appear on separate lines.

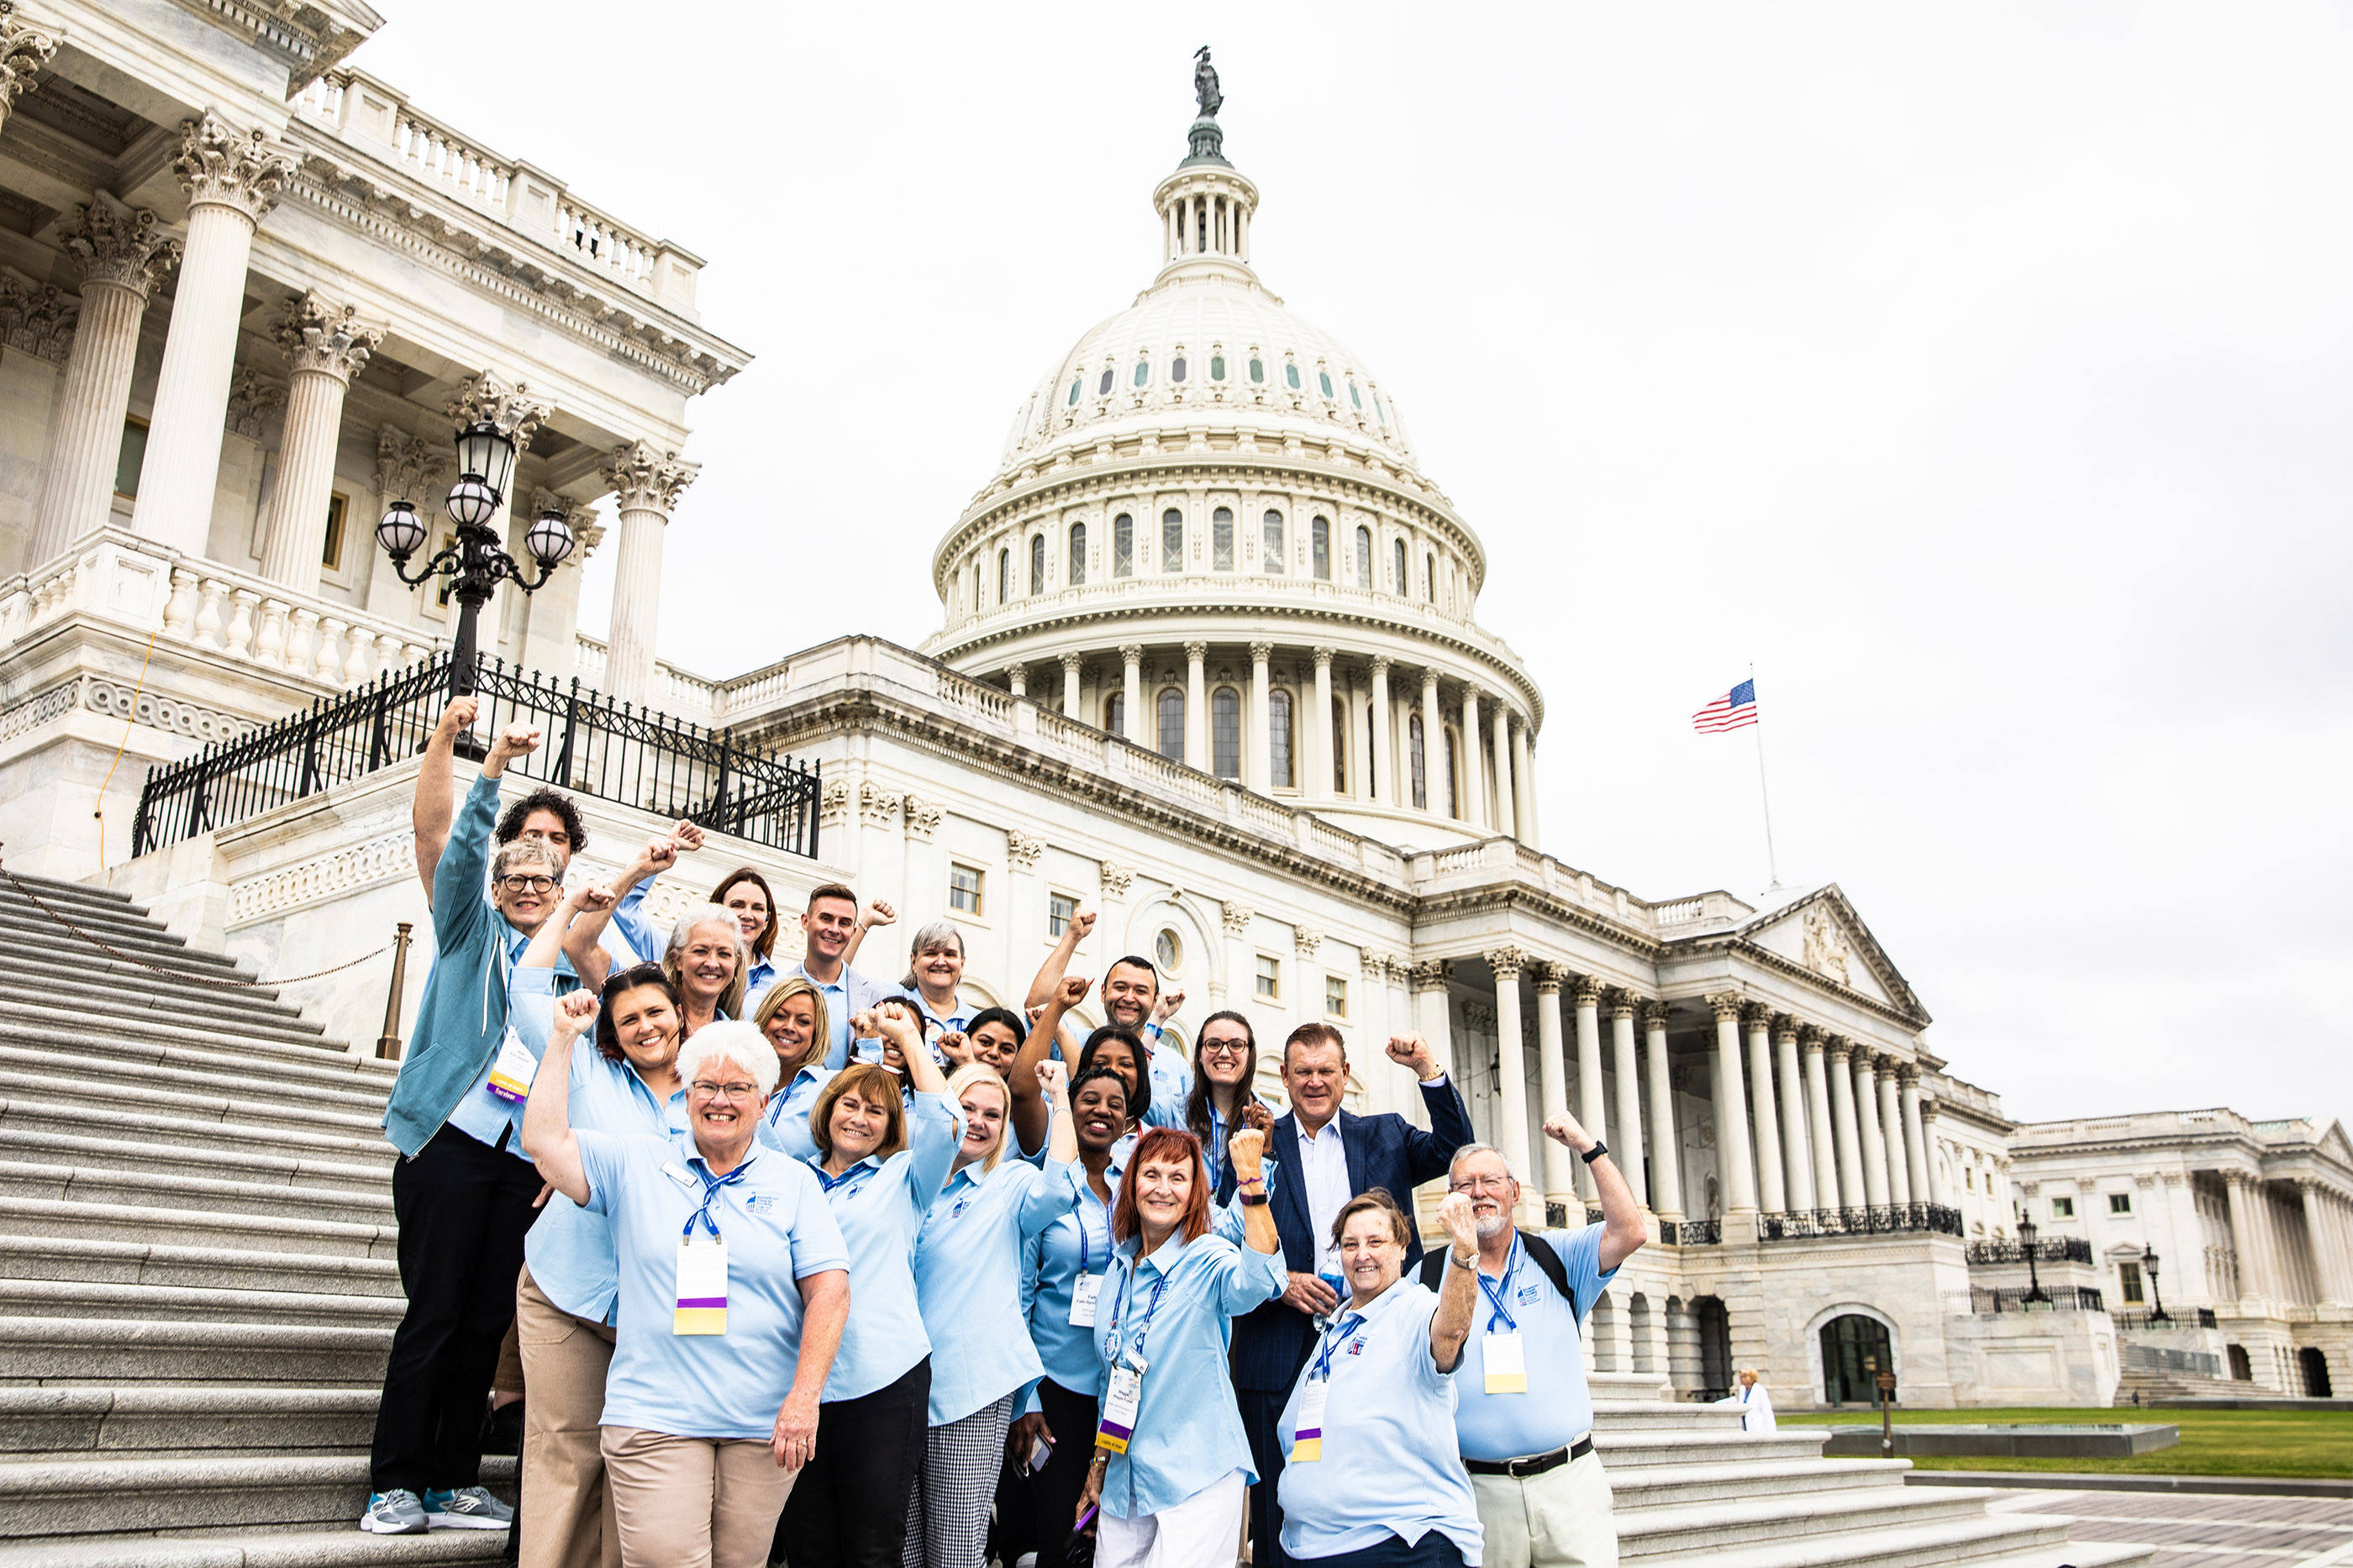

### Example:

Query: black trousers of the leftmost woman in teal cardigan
xmin=367 ymin=1128 xmax=539 ymax=1497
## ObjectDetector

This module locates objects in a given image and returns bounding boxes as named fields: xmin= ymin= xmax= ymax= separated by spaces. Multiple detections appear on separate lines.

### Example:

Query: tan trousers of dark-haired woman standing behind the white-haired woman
xmin=515 ymin=1266 xmax=621 ymax=1568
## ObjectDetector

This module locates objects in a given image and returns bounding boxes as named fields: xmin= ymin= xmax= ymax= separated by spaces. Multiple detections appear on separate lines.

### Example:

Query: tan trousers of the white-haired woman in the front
xmin=605 ymin=1427 xmax=800 ymax=1568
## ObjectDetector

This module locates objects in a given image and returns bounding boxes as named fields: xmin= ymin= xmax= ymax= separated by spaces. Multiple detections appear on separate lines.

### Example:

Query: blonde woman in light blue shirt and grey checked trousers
xmin=906 ymin=1062 xmax=1077 ymax=1568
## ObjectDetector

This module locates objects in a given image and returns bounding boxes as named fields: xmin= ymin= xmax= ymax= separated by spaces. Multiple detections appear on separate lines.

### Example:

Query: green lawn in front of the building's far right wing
xmin=1782 ymin=1406 xmax=2353 ymax=1476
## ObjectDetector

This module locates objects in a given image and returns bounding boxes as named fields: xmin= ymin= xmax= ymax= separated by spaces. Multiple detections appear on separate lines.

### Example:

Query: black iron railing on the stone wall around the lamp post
xmin=132 ymin=655 xmax=819 ymax=857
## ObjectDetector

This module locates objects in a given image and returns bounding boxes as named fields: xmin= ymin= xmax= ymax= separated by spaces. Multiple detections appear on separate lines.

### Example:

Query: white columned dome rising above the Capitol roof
xmin=924 ymin=74 xmax=1544 ymax=848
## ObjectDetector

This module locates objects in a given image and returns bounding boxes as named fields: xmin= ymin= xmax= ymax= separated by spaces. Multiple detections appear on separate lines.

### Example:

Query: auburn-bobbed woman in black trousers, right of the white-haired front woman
xmin=776 ymin=1003 xmax=965 ymax=1563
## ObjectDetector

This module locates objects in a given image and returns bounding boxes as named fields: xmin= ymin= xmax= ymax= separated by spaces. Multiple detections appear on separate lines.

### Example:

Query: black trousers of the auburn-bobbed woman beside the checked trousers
xmin=774 ymin=1356 xmax=932 ymax=1568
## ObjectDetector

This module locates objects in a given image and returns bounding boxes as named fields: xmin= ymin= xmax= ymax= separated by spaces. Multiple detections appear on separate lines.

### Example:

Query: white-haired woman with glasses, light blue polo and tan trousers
xmin=523 ymin=1022 xmax=850 ymax=1568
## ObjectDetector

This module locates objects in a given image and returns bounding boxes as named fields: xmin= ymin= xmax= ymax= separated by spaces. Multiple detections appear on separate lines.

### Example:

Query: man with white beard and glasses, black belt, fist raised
xmin=1424 ymin=1111 xmax=1642 ymax=1568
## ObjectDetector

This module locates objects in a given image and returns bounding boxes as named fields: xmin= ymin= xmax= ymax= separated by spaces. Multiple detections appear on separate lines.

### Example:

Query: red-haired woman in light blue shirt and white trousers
xmin=1077 ymin=1128 xmax=1289 ymax=1568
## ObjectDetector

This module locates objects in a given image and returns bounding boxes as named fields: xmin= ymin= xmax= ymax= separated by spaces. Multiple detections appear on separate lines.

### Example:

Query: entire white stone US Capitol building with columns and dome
xmin=0 ymin=0 xmax=2353 ymax=1406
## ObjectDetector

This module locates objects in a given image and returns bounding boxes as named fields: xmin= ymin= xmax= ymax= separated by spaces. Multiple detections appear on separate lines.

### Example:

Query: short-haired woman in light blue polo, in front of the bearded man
xmin=1276 ymin=1187 xmax=1480 ymax=1568
